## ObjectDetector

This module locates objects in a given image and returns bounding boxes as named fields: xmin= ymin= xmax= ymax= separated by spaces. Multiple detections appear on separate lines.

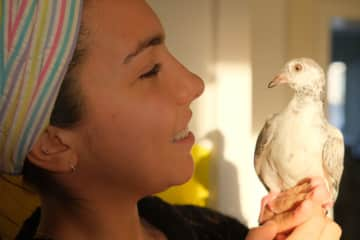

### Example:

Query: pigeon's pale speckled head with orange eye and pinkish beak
xmin=268 ymin=58 xmax=325 ymax=94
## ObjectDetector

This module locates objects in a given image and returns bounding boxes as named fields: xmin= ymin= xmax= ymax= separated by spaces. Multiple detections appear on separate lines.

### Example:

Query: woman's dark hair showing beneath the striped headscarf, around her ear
xmin=22 ymin=24 xmax=87 ymax=194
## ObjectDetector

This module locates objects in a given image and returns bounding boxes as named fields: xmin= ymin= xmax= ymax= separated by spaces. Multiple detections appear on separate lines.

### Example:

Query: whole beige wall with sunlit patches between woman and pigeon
xmin=148 ymin=0 xmax=360 ymax=226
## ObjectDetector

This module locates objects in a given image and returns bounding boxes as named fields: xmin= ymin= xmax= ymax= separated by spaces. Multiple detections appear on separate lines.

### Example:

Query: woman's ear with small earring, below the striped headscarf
xmin=27 ymin=126 xmax=78 ymax=173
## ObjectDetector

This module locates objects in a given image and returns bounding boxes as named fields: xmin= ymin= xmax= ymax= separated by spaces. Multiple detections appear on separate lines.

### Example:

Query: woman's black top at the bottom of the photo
xmin=16 ymin=197 xmax=248 ymax=240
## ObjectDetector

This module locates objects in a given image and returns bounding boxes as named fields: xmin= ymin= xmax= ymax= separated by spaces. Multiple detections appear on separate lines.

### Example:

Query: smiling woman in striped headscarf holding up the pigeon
xmin=0 ymin=0 xmax=340 ymax=240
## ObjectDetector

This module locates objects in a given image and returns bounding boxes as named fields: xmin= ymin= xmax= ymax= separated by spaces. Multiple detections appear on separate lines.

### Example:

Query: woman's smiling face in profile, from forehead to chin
xmin=71 ymin=0 xmax=204 ymax=194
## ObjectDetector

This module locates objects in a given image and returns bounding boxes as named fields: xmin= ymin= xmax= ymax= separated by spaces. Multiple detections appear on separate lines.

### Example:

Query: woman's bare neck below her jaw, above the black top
xmin=39 ymin=193 xmax=160 ymax=240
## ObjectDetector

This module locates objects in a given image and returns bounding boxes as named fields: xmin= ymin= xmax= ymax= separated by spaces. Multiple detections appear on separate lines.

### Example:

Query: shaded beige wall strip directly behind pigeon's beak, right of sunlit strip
xmin=251 ymin=0 xmax=291 ymax=139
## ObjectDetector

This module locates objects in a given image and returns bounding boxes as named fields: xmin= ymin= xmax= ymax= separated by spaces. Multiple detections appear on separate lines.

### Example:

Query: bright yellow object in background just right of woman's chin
xmin=156 ymin=143 xmax=212 ymax=207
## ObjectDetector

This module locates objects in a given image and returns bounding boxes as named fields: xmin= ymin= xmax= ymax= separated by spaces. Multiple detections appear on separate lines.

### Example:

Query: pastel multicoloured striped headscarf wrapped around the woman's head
xmin=0 ymin=0 xmax=82 ymax=174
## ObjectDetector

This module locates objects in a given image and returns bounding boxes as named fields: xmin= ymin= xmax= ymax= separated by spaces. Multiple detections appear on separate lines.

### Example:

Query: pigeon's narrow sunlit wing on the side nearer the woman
xmin=254 ymin=114 xmax=278 ymax=186
